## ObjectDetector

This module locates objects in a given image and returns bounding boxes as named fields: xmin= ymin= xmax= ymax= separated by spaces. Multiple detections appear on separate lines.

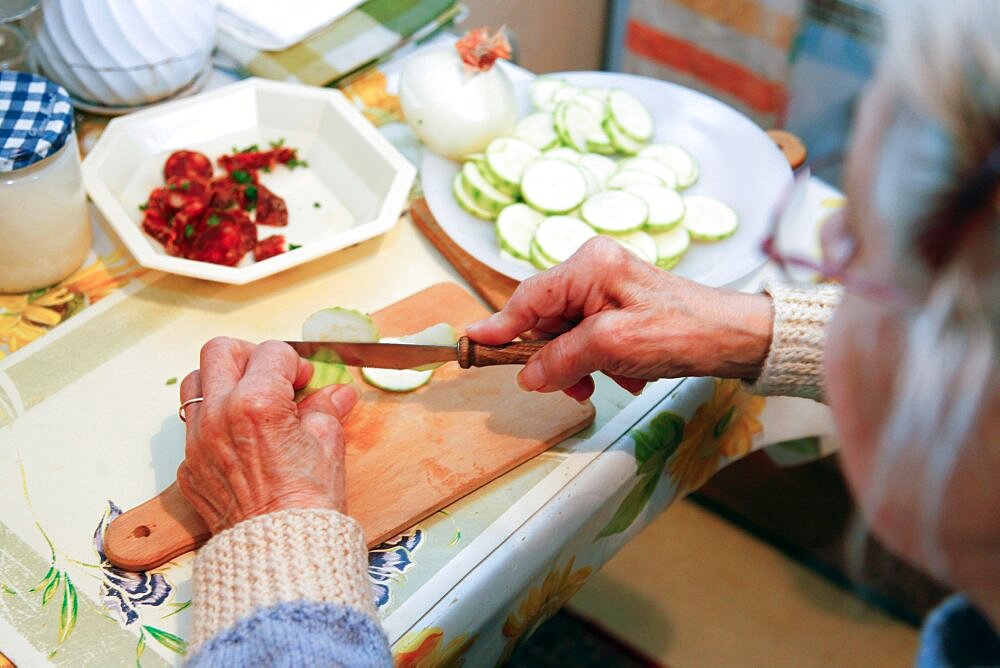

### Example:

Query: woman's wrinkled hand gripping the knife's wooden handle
xmin=467 ymin=237 xmax=772 ymax=401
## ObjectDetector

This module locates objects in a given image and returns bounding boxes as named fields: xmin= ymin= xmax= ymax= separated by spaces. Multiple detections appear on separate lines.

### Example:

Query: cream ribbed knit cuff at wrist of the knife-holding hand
xmin=749 ymin=283 xmax=843 ymax=401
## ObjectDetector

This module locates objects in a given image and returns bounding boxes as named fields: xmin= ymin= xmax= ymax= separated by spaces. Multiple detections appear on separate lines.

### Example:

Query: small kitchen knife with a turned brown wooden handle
xmin=285 ymin=336 xmax=548 ymax=369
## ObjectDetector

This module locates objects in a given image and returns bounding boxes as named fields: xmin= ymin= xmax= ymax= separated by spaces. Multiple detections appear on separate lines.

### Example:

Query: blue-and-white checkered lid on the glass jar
xmin=0 ymin=72 xmax=73 ymax=172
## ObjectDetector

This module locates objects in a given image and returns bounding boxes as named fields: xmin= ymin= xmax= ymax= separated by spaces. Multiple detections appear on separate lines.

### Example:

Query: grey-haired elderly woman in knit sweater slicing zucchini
xmin=178 ymin=0 xmax=1000 ymax=666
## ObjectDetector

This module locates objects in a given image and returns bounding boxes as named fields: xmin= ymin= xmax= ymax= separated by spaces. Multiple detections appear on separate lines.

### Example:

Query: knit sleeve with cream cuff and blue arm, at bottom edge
xmin=188 ymin=509 xmax=392 ymax=666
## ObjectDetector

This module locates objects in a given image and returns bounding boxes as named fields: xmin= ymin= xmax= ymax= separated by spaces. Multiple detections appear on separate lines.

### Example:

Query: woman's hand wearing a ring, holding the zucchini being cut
xmin=177 ymin=338 xmax=358 ymax=533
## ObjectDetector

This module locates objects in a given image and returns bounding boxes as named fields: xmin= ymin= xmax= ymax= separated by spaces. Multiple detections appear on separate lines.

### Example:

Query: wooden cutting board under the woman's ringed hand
xmin=105 ymin=283 xmax=594 ymax=570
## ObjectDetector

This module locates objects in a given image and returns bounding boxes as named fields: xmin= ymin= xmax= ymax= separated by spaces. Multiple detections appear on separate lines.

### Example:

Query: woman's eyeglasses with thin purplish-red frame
xmin=761 ymin=164 xmax=908 ymax=304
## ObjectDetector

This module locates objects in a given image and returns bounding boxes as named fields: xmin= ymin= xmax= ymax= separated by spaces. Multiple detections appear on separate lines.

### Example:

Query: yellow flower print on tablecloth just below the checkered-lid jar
xmin=0 ymin=249 xmax=146 ymax=358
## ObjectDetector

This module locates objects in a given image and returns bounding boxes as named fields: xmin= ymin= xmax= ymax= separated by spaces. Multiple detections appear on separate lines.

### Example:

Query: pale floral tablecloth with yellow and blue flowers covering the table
xmin=0 ymin=48 xmax=840 ymax=666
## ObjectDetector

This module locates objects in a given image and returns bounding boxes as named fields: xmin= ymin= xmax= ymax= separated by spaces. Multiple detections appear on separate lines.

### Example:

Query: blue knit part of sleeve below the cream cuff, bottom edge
xmin=188 ymin=602 xmax=392 ymax=668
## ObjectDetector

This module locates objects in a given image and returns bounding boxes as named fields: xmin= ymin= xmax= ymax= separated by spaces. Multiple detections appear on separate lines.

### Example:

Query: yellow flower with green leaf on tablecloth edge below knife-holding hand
xmin=594 ymin=379 xmax=765 ymax=541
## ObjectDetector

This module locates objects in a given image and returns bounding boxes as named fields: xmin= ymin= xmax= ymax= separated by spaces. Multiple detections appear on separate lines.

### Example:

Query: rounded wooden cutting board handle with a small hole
xmin=104 ymin=482 xmax=212 ymax=571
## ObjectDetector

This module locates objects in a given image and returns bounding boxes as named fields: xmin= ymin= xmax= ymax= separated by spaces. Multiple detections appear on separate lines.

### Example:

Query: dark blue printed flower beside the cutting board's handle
xmin=94 ymin=500 xmax=173 ymax=626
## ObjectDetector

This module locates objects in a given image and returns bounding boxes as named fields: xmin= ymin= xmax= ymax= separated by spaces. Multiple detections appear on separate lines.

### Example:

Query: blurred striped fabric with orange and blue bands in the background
xmin=609 ymin=0 xmax=880 ymax=184
